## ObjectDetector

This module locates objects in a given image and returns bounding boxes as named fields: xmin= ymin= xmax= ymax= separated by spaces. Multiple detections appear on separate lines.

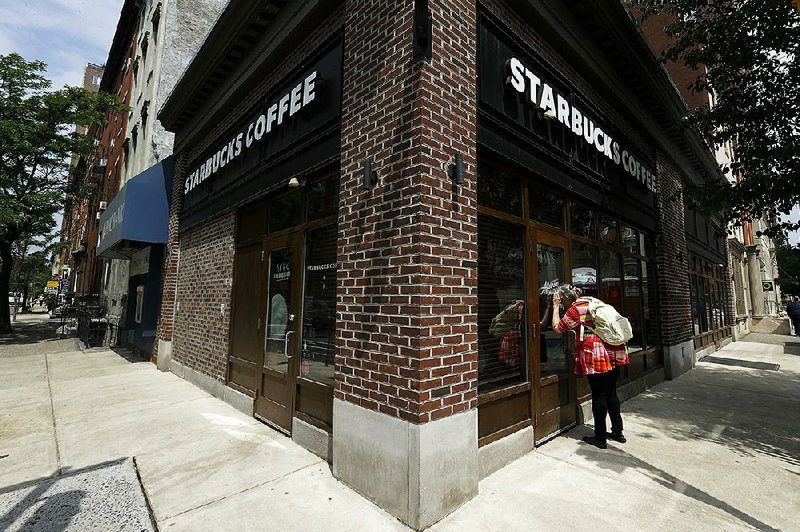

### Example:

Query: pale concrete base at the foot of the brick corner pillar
xmin=333 ymin=399 xmax=478 ymax=530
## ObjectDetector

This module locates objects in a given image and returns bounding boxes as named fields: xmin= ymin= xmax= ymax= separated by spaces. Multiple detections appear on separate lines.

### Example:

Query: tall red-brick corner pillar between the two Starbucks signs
xmin=334 ymin=0 xmax=477 ymax=423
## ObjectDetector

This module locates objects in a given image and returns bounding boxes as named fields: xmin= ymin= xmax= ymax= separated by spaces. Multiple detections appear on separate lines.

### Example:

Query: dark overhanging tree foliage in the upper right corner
xmin=630 ymin=0 xmax=800 ymax=230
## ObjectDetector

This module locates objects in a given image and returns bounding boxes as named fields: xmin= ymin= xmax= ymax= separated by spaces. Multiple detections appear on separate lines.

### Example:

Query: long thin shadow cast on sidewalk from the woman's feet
xmin=576 ymin=436 xmax=778 ymax=531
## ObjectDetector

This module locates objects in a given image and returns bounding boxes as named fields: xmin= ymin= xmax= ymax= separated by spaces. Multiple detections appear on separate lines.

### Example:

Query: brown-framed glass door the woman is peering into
xmin=532 ymin=230 xmax=577 ymax=442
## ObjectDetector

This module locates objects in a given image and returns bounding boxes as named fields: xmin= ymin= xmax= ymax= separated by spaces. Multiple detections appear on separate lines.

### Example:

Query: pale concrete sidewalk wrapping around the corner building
xmin=0 ymin=320 xmax=800 ymax=531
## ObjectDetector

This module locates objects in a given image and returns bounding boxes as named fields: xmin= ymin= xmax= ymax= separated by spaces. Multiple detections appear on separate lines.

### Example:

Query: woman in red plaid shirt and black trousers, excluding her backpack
xmin=553 ymin=285 xmax=630 ymax=449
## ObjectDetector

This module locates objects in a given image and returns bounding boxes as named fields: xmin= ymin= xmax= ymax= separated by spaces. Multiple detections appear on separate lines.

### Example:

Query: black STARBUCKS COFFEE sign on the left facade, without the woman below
xmin=183 ymin=40 xmax=342 ymax=216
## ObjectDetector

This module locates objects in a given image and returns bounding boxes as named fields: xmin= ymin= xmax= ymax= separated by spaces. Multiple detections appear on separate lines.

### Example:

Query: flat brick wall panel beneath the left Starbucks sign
xmin=172 ymin=211 xmax=236 ymax=382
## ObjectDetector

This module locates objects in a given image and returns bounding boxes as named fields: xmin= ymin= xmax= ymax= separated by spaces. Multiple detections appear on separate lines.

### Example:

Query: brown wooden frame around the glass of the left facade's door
xmin=253 ymin=230 xmax=304 ymax=434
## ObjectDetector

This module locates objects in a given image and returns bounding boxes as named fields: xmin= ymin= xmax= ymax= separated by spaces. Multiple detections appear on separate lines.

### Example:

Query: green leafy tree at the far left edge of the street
xmin=0 ymin=53 xmax=126 ymax=334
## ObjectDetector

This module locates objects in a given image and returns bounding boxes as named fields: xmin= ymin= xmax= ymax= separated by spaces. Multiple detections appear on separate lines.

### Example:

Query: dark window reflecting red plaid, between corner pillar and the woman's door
xmin=478 ymin=215 xmax=527 ymax=392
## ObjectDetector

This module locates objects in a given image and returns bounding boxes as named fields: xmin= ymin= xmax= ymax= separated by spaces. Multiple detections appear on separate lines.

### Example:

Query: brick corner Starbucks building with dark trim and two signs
xmin=157 ymin=0 xmax=730 ymax=529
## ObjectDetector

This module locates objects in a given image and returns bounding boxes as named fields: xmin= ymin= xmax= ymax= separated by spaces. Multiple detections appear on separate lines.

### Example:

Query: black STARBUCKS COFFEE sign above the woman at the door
xmin=478 ymin=16 xmax=657 ymax=198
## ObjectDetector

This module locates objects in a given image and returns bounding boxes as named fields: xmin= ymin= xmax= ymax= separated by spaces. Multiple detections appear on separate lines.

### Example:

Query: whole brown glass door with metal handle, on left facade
xmin=255 ymin=234 xmax=302 ymax=432
